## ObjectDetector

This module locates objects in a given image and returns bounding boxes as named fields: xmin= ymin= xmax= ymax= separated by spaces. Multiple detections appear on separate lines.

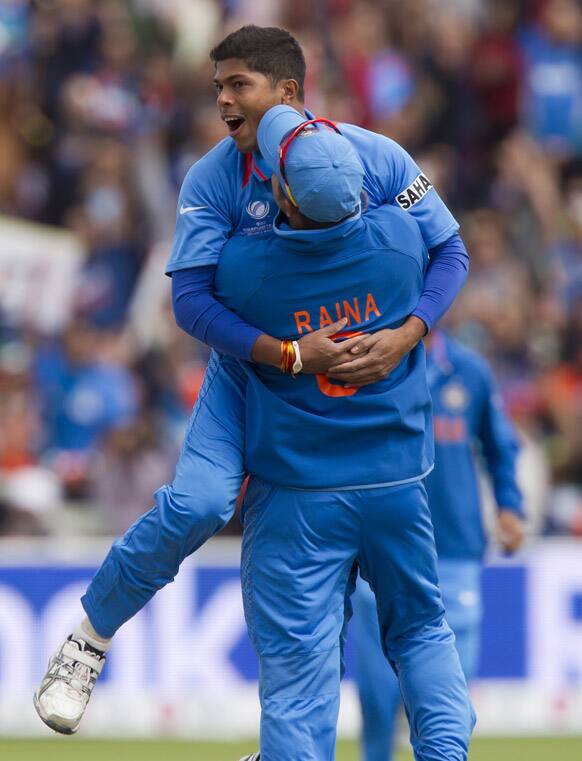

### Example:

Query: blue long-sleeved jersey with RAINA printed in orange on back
xmin=216 ymin=206 xmax=433 ymax=489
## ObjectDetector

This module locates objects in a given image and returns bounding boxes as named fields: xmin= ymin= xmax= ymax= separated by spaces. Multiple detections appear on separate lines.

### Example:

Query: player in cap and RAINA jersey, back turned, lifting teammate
xmin=216 ymin=105 xmax=473 ymax=761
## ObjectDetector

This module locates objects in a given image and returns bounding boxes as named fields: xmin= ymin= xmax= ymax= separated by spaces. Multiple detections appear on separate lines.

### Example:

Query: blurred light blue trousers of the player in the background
xmin=352 ymin=559 xmax=481 ymax=761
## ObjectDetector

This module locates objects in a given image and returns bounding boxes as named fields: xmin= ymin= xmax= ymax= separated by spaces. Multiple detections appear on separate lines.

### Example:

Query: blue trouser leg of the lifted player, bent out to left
xmin=81 ymin=352 xmax=246 ymax=637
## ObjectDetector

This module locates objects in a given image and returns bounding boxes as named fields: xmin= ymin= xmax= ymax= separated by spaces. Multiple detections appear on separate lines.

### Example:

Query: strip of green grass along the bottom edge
xmin=0 ymin=737 xmax=582 ymax=761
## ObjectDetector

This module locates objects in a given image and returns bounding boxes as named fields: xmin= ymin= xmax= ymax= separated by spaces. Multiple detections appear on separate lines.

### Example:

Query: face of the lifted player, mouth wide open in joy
xmin=214 ymin=58 xmax=293 ymax=152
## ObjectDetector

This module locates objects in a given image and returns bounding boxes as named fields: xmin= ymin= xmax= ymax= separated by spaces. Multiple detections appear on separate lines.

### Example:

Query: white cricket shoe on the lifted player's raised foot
xmin=34 ymin=635 xmax=105 ymax=735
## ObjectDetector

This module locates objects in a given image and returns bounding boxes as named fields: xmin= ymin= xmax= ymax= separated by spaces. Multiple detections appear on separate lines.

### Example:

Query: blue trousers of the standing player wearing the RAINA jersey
xmin=241 ymin=479 xmax=474 ymax=761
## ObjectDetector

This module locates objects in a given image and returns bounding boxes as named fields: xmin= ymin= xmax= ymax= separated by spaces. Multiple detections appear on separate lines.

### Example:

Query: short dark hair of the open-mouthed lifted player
xmin=210 ymin=24 xmax=305 ymax=101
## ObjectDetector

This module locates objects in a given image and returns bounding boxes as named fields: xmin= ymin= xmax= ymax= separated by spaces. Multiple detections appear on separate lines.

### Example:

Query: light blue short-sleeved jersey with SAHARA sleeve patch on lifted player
xmin=166 ymin=119 xmax=459 ymax=274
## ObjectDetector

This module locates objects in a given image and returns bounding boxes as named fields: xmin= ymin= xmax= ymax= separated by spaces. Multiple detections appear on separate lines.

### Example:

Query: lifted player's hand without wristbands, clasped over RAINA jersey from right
xmin=327 ymin=317 xmax=426 ymax=387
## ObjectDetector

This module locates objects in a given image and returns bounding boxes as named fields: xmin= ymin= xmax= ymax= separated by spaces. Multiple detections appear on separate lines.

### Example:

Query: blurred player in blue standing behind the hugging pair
xmin=353 ymin=331 xmax=524 ymax=761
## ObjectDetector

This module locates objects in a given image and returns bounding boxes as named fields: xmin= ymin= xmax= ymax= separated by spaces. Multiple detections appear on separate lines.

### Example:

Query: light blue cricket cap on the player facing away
xmin=257 ymin=105 xmax=364 ymax=222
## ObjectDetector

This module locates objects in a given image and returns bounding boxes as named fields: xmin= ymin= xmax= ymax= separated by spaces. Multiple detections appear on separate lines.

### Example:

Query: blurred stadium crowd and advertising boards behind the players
xmin=0 ymin=0 xmax=582 ymax=761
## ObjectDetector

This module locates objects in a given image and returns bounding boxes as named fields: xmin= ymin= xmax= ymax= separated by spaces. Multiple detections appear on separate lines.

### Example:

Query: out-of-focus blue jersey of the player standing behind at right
xmin=426 ymin=331 xmax=523 ymax=560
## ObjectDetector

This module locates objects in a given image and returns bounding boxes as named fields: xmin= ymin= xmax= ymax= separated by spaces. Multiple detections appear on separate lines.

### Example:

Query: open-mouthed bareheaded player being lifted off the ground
xmin=35 ymin=26 xmax=468 ymax=734
